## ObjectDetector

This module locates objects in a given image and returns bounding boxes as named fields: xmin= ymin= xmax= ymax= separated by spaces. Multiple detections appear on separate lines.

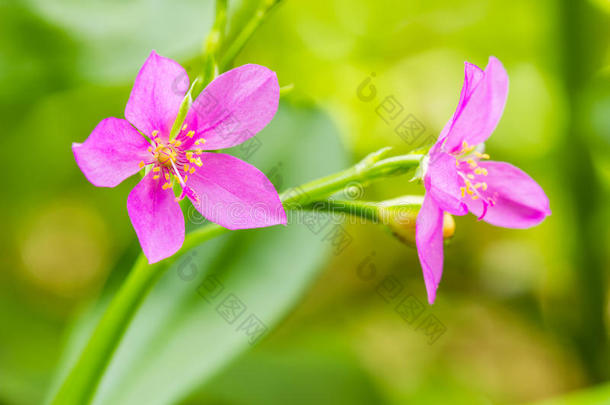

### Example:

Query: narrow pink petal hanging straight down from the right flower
xmin=415 ymin=195 xmax=443 ymax=304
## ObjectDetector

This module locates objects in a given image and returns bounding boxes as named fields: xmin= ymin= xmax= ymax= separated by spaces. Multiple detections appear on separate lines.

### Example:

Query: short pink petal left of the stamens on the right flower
xmin=425 ymin=152 xmax=468 ymax=215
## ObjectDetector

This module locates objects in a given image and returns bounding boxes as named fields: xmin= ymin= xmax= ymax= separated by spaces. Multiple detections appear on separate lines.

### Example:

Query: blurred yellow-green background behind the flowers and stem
xmin=0 ymin=0 xmax=610 ymax=405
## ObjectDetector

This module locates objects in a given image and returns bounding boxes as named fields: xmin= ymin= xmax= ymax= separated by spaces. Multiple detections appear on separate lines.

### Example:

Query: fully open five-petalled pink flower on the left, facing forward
xmin=72 ymin=51 xmax=286 ymax=263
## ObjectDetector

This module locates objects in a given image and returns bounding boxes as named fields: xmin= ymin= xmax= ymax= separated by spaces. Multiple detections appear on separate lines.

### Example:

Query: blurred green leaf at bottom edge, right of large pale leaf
xmin=186 ymin=340 xmax=390 ymax=405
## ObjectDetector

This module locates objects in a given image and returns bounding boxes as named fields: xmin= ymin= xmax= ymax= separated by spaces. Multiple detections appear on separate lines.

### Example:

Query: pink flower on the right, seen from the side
xmin=415 ymin=57 xmax=551 ymax=304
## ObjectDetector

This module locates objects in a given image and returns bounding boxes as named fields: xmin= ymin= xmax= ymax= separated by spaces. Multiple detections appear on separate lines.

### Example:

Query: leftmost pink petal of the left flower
xmin=72 ymin=118 xmax=151 ymax=187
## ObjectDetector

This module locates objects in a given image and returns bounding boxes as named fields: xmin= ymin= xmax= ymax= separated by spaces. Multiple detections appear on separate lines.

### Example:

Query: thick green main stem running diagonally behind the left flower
xmin=51 ymin=149 xmax=422 ymax=405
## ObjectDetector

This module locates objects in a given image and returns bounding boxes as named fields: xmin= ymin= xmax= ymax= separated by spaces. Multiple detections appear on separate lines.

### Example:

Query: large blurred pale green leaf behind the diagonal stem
xmin=51 ymin=105 xmax=346 ymax=404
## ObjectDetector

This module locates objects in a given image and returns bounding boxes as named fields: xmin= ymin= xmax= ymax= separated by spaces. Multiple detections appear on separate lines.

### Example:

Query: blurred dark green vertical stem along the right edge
xmin=560 ymin=0 xmax=610 ymax=383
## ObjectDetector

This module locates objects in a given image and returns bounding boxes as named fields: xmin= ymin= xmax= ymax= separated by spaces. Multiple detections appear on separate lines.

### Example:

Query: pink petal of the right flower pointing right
xmin=465 ymin=162 xmax=551 ymax=228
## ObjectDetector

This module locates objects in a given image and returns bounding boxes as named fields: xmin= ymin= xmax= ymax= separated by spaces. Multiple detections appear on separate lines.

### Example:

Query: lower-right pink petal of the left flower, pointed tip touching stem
xmin=187 ymin=153 xmax=286 ymax=229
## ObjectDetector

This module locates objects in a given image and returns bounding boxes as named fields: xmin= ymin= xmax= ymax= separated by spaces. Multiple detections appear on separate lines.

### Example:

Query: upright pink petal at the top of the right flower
xmin=443 ymin=56 xmax=508 ymax=152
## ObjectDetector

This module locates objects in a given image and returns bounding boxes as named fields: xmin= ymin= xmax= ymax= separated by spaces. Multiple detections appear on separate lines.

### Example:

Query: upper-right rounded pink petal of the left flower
xmin=183 ymin=65 xmax=280 ymax=150
